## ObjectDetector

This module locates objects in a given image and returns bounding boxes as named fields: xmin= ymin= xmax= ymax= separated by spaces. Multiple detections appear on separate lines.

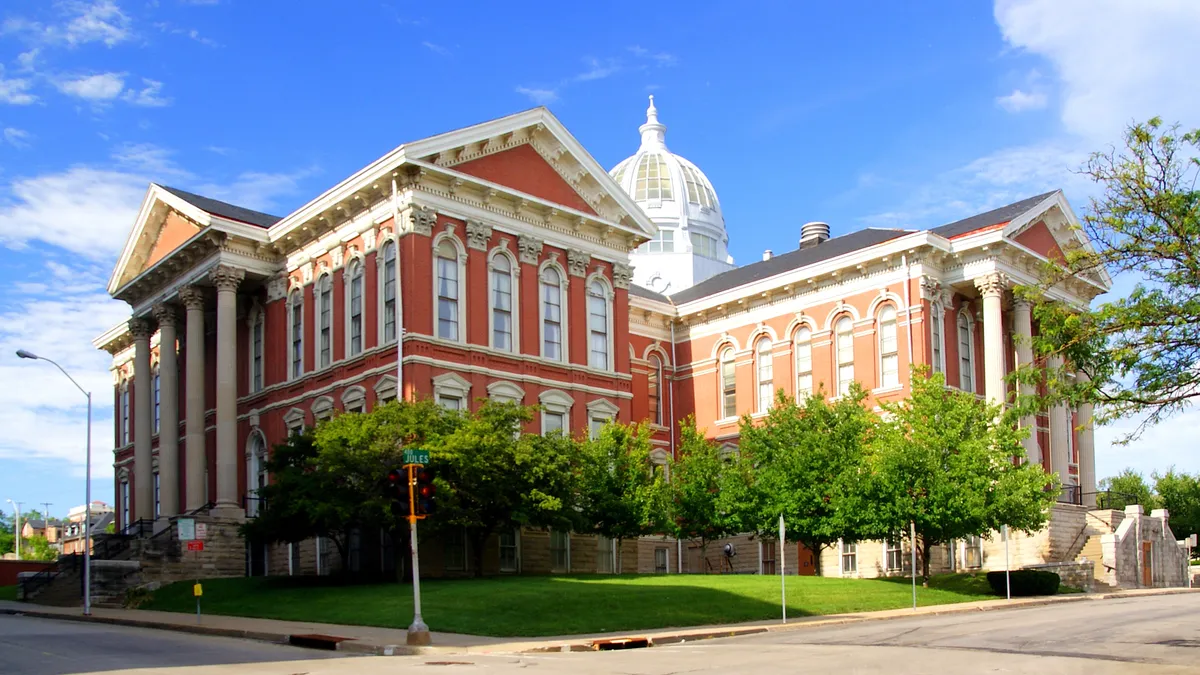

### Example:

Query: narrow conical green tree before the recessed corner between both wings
xmin=655 ymin=417 xmax=737 ymax=558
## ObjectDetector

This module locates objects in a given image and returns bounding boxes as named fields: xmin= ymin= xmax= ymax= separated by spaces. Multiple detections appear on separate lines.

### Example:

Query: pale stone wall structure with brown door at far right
xmin=1100 ymin=504 xmax=1187 ymax=589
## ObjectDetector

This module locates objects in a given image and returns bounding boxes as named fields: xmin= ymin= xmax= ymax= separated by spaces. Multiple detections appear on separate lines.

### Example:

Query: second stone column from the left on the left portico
xmin=154 ymin=305 xmax=179 ymax=518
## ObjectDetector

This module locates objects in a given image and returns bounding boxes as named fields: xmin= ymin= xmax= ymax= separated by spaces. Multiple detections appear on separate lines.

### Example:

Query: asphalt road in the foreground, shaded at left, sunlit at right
xmin=0 ymin=593 xmax=1200 ymax=675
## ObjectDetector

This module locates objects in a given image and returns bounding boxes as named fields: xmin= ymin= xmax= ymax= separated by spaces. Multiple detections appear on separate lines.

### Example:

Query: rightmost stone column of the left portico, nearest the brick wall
xmin=209 ymin=265 xmax=246 ymax=518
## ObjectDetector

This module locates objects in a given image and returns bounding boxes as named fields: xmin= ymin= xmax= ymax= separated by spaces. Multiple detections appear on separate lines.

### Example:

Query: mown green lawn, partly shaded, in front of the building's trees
xmin=142 ymin=574 xmax=991 ymax=637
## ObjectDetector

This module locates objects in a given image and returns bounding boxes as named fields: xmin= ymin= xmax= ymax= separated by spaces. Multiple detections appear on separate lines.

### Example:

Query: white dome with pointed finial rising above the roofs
xmin=608 ymin=96 xmax=733 ymax=292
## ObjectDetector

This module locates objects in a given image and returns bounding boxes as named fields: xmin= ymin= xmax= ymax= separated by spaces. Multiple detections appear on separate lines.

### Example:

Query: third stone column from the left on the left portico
xmin=179 ymin=283 xmax=208 ymax=512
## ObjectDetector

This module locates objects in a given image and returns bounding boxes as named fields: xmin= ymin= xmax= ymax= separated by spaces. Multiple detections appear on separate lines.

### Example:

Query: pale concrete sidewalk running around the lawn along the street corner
xmin=0 ymin=589 xmax=1200 ymax=656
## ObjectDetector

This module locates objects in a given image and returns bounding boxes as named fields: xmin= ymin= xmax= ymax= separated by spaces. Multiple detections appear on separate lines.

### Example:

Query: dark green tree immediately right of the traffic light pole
xmin=431 ymin=401 xmax=578 ymax=577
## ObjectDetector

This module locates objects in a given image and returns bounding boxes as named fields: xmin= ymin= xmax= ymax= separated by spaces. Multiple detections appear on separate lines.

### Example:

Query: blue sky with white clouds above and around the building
xmin=0 ymin=0 xmax=1200 ymax=521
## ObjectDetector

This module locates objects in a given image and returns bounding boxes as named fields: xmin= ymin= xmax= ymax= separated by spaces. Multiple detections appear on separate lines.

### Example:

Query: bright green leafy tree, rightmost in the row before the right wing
xmin=857 ymin=368 xmax=1058 ymax=585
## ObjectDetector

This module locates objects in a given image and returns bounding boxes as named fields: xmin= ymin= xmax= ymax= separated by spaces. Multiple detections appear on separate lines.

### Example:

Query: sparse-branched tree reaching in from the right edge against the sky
xmin=1027 ymin=118 xmax=1200 ymax=441
